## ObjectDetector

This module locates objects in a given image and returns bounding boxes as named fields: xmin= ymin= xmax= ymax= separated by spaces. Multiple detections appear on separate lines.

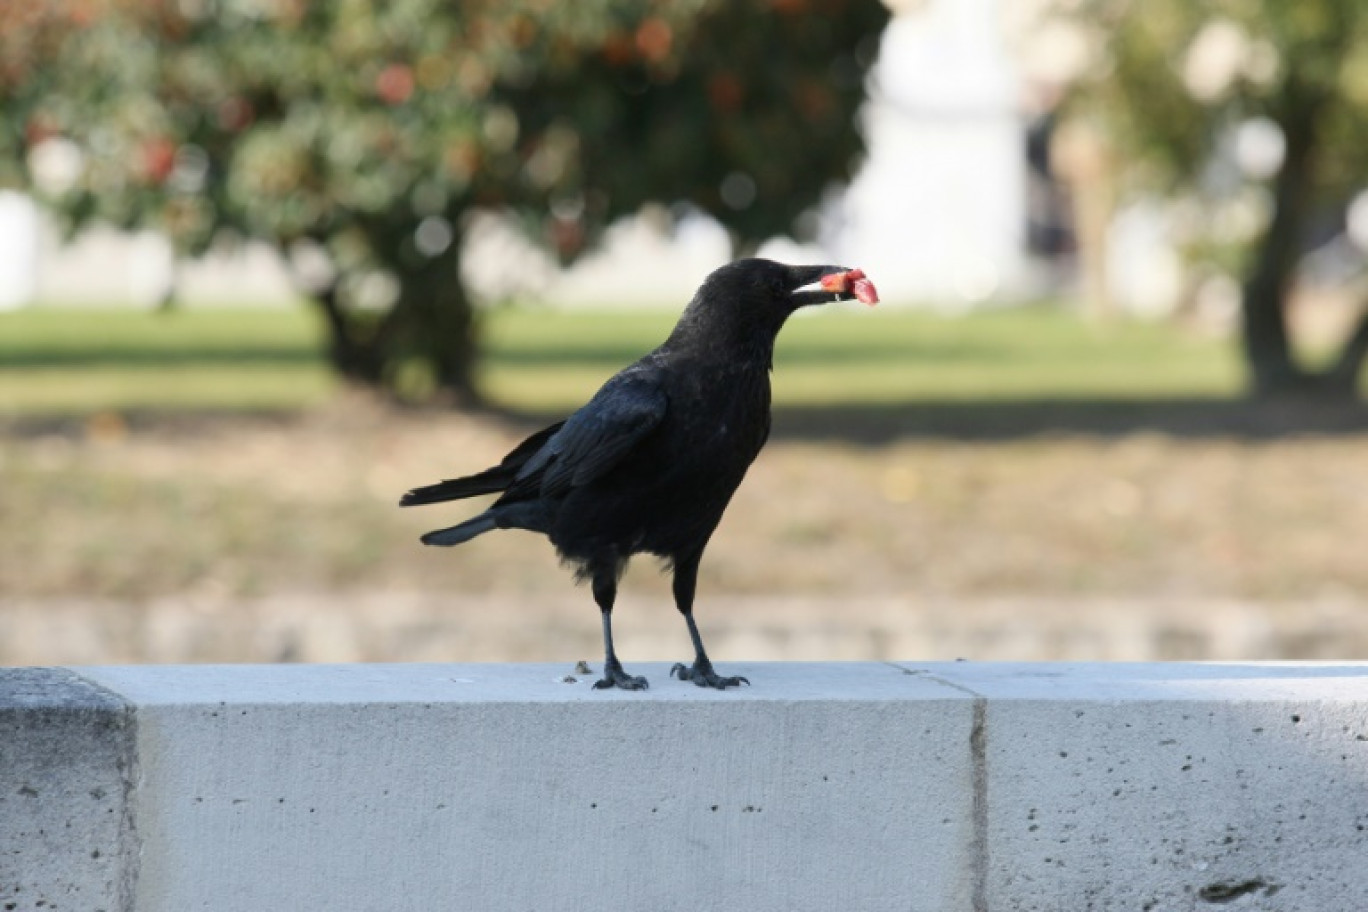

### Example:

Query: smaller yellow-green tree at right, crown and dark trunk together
xmin=1062 ymin=0 xmax=1368 ymax=397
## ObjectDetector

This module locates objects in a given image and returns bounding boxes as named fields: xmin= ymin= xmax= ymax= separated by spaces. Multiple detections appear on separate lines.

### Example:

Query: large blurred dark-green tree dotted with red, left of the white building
xmin=0 ymin=0 xmax=888 ymax=399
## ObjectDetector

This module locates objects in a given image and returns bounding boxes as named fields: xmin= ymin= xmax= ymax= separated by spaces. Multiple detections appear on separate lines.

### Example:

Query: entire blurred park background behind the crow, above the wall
xmin=0 ymin=0 xmax=1368 ymax=665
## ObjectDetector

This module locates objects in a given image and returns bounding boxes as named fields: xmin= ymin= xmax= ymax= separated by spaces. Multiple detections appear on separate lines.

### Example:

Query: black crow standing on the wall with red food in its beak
xmin=399 ymin=260 xmax=878 ymax=690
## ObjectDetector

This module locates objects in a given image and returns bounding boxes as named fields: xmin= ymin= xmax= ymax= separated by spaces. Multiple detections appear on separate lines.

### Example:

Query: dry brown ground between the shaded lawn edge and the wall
xmin=0 ymin=401 xmax=1368 ymax=663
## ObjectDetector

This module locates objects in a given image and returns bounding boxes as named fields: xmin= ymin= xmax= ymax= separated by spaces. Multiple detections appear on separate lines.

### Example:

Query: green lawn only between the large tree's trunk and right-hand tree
xmin=483 ymin=308 xmax=1242 ymax=409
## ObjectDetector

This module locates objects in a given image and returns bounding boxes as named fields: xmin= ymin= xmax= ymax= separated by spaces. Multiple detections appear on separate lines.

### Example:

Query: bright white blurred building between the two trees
xmin=830 ymin=0 xmax=1026 ymax=304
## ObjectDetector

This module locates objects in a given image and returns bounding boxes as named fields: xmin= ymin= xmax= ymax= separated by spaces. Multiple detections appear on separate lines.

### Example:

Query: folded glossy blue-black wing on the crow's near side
xmin=506 ymin=365 xmax=669 ymax=499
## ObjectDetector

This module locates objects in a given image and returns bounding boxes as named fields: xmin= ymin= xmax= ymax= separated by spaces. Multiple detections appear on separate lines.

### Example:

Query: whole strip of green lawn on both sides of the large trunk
xmin=0 ymin=308 xmax=1241 ymax=414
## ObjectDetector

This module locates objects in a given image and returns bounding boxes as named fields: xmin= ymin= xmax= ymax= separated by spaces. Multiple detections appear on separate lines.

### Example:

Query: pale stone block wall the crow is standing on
xmin=0 ymin=662 xmax=1368 ymax=912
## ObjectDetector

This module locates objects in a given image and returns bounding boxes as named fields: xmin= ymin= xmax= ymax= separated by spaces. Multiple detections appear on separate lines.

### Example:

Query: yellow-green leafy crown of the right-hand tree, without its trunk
xmin=1068 ymin=0 xmax=1368 ymax=196
